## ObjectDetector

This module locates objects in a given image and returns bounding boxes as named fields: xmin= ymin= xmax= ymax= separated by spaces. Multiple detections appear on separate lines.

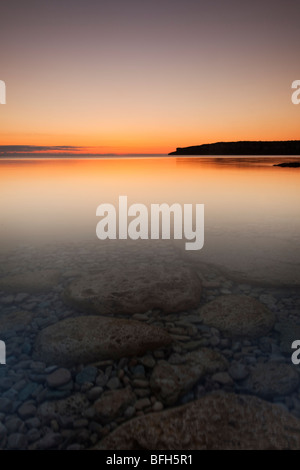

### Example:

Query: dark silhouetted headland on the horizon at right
xmin=169 ymin=140 xmax=300 ymax=156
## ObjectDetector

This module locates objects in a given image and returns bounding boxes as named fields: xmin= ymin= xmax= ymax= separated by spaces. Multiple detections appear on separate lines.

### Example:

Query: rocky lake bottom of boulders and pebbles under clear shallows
xmin=0 ymin=242 xmax=300 ymax=450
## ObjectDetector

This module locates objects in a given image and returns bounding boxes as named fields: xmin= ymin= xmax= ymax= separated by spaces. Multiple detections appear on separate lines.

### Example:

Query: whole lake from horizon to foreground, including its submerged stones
xmin=0 ymin=157 xmax=300 ymax=450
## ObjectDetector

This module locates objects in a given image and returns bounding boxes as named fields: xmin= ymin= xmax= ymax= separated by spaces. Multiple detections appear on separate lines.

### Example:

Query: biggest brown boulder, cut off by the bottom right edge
xmin=96 ymin=393 xmax=300 ymax=450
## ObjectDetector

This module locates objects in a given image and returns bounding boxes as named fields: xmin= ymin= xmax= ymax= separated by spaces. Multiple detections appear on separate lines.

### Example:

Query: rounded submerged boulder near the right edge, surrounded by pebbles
xmin=199 ymin=295 xmax=275 ymax=338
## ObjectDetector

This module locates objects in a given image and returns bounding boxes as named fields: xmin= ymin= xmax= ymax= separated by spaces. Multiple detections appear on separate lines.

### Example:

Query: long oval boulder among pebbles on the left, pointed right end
xmin=34 ymin=316 xmax=172 ymax=366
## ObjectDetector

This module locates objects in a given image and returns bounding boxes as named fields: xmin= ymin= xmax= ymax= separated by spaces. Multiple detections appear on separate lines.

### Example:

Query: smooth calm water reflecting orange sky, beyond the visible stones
xmin=0 ymin=157 xmax=300 ymax=284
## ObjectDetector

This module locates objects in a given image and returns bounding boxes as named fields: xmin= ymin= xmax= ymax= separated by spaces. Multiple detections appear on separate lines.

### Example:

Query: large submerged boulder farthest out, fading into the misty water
xmin=63 ymin=264 xmax=201 ymax=315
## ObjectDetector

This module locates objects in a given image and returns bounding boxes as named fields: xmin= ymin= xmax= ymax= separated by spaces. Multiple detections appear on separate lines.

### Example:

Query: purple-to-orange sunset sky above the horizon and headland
xmin=0 ymin=0 xmax=300 ymax=156
